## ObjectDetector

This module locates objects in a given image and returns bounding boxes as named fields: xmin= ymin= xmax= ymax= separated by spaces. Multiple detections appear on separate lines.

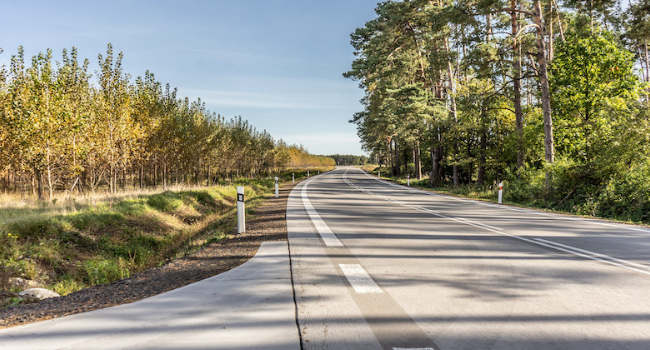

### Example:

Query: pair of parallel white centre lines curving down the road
xmin=343 ymin=171 xmax=650 ymax=275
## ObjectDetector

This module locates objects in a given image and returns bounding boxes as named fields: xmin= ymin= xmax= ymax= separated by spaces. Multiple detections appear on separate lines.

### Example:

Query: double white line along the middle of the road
xmin=344 ymin=168 xmax=650 ymax=275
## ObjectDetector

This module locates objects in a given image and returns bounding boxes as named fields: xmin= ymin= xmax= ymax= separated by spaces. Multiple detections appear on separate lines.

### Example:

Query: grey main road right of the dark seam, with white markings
xmin=287 ymin=168 xmax=650 ymax=350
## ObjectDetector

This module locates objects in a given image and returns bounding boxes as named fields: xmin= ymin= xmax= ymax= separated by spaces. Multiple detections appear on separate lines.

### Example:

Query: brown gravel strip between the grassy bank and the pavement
xmin=0 ymin=184 xmax=294 ymax=329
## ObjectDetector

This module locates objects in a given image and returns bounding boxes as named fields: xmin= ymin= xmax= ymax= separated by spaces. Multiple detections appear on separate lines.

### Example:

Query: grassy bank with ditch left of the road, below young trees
xmin=0 ymin=169 xmax=332 ymax=306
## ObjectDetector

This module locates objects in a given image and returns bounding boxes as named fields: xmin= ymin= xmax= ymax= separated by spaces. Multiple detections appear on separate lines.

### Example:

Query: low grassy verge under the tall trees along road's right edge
xmin=364 ymin=167 xmax=650 ymax=225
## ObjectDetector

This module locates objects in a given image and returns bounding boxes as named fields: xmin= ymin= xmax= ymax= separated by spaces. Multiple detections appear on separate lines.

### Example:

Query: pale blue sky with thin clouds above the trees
xmin=0 ymin=0 xmax=378 ymax=155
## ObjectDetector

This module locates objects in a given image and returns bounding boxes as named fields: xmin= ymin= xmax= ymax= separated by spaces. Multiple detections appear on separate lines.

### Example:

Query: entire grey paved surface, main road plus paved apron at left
xmin=5 ymin=168 xmax=650 ymax=350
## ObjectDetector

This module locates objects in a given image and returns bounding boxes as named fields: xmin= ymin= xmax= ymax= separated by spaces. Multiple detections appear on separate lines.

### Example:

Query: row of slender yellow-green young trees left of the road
xmin=0 ymin=44 xmax=320 ymax=199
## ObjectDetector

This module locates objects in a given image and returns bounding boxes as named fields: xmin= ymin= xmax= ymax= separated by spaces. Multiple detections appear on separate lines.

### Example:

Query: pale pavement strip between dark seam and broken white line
xmin=287 ymin=175 xmax=382 ymax=350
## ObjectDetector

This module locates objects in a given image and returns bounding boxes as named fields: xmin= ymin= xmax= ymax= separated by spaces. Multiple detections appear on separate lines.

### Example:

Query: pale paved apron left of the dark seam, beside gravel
xmin=0 ymin=242 xmax=300 ymax=350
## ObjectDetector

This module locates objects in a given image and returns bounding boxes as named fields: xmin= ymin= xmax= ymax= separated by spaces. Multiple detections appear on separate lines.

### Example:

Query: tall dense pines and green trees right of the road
xmin=344 ymin=0 xmax=650 ymax=222
